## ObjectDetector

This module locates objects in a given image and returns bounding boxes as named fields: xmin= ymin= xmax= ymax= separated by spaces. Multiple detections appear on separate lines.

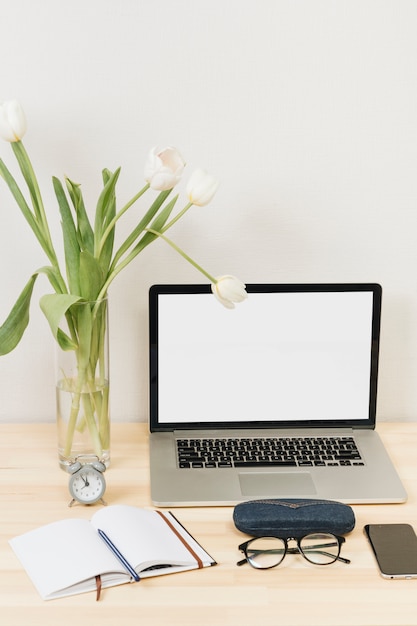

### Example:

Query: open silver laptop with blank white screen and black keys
xmin=149 ymin=283 xmax=407 ymax=507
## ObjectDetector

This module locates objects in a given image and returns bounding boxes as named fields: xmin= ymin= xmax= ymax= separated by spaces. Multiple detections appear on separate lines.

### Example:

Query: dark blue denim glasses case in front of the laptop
xmin=233 ymin=499 xmax=355 ymax=539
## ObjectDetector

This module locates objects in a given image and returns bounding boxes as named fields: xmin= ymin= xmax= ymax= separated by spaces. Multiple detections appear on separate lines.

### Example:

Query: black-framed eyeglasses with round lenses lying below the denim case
xmin=236 ymin=533 xmax=350 ymax=569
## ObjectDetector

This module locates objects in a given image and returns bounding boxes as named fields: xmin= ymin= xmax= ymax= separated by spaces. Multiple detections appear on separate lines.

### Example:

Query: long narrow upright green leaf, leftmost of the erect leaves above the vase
xmin=53 ymin=176 xmax=80 ymax=294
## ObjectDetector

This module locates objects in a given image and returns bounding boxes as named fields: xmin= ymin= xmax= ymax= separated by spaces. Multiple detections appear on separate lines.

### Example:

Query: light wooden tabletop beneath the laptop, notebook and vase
xmin=0 ymin=423 xmax=417 ymax=626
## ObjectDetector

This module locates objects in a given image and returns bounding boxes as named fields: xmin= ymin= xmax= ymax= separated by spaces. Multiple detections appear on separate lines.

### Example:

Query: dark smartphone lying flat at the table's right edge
xmin=364 ymin=524 xmax=417 ymax=578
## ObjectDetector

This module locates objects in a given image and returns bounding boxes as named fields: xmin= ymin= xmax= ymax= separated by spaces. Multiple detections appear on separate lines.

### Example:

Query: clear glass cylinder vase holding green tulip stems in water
xmin=56 ymin=299 xmax=110 ymax=470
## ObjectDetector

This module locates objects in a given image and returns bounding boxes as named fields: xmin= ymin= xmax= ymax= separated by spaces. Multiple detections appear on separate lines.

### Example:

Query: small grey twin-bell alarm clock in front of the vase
xmin=68 ymin=461 xmax=106 ymax=506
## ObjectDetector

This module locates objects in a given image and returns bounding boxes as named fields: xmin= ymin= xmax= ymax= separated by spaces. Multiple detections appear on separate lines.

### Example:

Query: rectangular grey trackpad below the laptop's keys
xmin=239 ymin=472 xmax=316 ymax=498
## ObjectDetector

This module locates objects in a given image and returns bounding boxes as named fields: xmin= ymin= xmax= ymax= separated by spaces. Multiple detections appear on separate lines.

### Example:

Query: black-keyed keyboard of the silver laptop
xmin=177 ymin=437 xmax=365 ymax=469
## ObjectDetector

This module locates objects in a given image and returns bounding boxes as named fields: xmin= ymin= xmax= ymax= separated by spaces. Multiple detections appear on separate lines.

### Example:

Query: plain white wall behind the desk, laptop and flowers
xmin=0 ymin=0 xmax=417 ymax=421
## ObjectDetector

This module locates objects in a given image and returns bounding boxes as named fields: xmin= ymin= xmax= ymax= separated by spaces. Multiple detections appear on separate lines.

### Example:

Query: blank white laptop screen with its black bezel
xmin=149 ymin=284 xmax=381 ymax=430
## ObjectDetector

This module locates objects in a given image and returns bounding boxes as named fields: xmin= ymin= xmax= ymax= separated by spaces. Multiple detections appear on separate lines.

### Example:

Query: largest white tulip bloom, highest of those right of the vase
xmin=145 ymin=146 xmax=185 ymax=191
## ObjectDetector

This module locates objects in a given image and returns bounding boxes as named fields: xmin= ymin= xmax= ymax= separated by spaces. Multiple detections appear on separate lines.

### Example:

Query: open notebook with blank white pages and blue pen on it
xmin=10 ymin=504 xmax=216 ymax=600
